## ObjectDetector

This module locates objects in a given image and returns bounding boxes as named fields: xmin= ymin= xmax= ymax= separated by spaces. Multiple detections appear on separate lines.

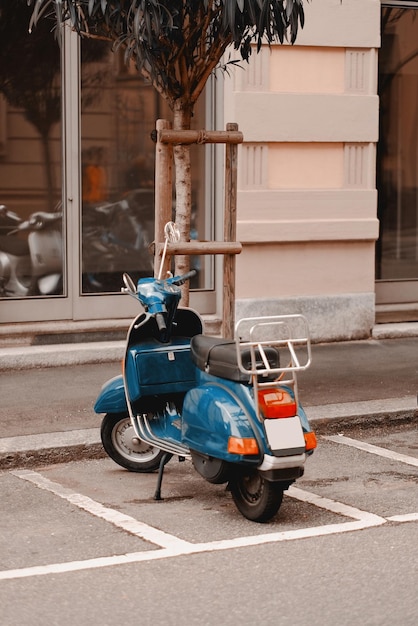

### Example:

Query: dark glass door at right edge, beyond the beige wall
xmin=376 ymin=3 xmax=418 ymax=304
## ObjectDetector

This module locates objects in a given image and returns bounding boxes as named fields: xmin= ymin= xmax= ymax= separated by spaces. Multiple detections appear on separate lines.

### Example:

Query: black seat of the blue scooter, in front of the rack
xmin=190 ymin=335 xmax=280 ymax=383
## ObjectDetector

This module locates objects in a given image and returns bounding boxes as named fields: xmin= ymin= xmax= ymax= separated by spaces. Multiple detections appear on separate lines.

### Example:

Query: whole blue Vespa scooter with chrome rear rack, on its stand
xmin=94 ymin=260 xmax=316 ymax=522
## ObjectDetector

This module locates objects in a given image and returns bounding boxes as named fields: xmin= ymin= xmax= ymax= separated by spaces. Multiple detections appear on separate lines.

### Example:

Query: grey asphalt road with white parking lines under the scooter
xmin=0 ymin=425 xmax=418 ymax=626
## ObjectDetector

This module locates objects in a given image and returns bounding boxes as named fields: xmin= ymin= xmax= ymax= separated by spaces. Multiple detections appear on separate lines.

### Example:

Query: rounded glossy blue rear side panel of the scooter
xmin=182 ymin=383 xmax=263 ymax=463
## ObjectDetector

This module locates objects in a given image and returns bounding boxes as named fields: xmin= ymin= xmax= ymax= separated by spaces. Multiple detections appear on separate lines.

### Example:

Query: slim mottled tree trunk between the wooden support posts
xmin=173 ymin=101 xmax=192 ymax=306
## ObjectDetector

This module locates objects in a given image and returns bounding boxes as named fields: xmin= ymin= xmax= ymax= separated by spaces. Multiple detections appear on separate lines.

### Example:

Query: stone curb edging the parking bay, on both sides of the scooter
xmin=0 ymin=396 xmax=418 ymax=470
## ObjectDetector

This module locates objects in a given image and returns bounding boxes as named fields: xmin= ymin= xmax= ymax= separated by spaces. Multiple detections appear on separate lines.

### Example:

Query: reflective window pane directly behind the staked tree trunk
xmin=81 ymin=40 xmax=205 ymax=294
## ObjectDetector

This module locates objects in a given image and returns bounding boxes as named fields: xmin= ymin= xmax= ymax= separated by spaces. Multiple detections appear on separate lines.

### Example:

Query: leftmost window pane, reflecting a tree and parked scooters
xmin=0 ymin=2 xmax=64 ymax=298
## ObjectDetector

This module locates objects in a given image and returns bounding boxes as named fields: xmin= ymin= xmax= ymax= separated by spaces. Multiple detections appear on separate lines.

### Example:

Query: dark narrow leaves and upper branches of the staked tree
xmin=27 ymin=0 xmax=304 ymax=105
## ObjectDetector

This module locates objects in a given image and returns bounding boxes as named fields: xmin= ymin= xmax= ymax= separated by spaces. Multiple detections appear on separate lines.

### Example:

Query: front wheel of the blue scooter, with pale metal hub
xmin=100 ymin=413 xmax=164 ymax=472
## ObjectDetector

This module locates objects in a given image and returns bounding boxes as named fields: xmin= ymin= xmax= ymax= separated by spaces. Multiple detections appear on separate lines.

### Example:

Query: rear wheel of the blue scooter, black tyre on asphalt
xmin=229 ymin=468 xmax=283 ymax=522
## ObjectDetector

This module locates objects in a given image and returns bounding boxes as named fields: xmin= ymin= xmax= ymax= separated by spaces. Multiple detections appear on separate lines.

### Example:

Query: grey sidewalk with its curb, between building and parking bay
xmin=0 ymin=323 xmax=418 ymax=468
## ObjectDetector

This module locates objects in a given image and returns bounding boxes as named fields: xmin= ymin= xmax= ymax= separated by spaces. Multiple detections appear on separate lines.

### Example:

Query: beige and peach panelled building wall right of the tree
xmin=224 ymin=0 xmax=380 ymax=341
